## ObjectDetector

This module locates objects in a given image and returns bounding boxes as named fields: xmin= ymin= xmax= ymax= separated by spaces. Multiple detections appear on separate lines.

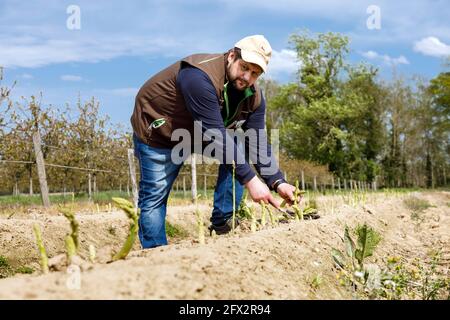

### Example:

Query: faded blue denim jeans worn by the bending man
xmin=133 ymin=136 xmax=244 ymax=249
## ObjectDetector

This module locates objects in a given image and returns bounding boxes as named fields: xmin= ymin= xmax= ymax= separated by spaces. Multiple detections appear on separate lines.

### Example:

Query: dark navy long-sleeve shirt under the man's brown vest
xmin=177 ymin=66 xmax=283 ymax=186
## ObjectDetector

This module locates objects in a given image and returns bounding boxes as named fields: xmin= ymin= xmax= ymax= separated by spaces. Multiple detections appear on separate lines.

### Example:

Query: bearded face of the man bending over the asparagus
xmin=227 ymin=52 xmax=262 ymax=91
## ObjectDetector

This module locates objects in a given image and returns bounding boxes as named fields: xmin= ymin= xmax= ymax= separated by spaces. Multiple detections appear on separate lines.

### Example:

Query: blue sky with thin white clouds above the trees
xmin=0 ymin=0 xmax=450 ymax=127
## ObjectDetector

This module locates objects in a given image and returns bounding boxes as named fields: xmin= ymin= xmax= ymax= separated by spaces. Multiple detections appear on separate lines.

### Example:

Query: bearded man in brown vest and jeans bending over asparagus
xmin=131 ymin=35 xmax=295 ymax=248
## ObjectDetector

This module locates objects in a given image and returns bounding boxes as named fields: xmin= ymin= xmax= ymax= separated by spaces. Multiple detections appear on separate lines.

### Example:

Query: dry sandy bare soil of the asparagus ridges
xmin=0 ymin=191 xmax=450 ymax=299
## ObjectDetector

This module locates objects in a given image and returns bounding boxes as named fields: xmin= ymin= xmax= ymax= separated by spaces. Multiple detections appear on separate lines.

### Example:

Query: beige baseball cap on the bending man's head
xmin=234 ymin=34 xmax=272 ymax=72
